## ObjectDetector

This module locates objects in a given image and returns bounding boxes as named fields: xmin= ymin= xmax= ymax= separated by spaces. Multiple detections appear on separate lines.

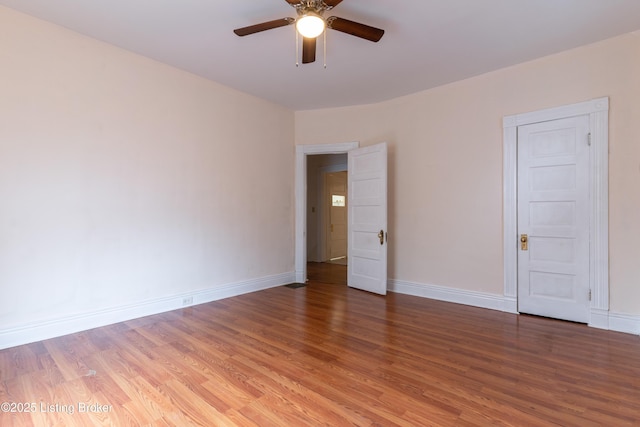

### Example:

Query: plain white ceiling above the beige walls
xmin=0 ymin=0 xmax=640 ymax=110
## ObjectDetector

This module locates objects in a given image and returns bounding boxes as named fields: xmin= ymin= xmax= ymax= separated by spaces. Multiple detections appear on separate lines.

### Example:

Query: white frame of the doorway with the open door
xmin=295 ymin=142 xmax=360 ymax=283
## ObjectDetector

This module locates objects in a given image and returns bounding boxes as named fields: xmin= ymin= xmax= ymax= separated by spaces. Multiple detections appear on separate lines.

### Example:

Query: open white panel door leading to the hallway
xmin=347 ymin=143 xmax=387 ymax=295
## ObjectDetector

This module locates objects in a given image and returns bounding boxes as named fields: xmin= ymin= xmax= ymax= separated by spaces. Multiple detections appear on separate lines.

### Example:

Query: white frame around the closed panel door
xmin=503 ymin=97 xmax=609 ymax=329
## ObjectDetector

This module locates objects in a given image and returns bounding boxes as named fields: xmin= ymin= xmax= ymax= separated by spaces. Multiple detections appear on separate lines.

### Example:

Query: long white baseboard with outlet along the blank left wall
xmin=0 ymin=272 xmax=295 ymax=349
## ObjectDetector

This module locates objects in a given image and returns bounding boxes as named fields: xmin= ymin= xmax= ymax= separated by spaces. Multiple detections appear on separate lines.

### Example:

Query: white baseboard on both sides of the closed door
xmin=387 ymin=279 xmax=640 ymax=335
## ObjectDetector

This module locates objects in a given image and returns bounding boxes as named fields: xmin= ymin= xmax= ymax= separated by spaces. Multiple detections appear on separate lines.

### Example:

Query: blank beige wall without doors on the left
xmin=0 ymin=7 xmax=294 ymax=331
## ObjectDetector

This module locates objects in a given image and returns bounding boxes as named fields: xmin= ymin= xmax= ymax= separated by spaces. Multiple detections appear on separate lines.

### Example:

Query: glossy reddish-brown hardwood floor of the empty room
xmin=0 ymin=265 xmax=640 ymax=426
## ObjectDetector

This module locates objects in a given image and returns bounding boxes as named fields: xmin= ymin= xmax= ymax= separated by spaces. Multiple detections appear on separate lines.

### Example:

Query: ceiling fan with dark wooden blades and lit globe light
xmin=233 ymin=0 xmax=384 ymax=64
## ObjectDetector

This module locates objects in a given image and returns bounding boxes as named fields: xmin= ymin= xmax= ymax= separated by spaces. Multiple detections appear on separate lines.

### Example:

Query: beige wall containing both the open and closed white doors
xmin=295 ymin=33 xmax=640 ymax=314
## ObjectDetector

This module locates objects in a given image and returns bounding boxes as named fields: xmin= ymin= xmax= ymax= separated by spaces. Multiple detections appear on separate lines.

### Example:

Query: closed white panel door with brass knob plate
xmin=517 ymin=116 xmax=590 ymax=323
